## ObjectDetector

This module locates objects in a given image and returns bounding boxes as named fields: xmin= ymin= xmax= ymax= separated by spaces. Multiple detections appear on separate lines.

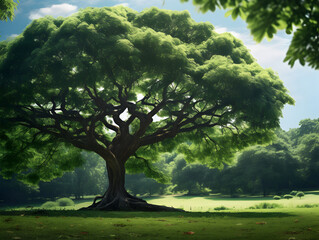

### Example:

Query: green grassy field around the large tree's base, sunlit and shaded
xmin=0 ymin=193 xmax=319 ymax=240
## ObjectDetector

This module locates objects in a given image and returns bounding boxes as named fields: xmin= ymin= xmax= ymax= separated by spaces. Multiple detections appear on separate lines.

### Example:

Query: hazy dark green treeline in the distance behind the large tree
xmin=0 ymin=119 xmax=319 ymax=203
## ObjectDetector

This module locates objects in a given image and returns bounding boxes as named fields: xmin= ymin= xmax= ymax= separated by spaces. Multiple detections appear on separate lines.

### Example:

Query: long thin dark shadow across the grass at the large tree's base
xmin=0 ymin=210 xmax=294 ymax=218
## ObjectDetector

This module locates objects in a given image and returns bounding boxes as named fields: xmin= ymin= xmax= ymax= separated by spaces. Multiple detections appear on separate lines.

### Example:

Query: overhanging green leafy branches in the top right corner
xmin=181 ymin=0 xmax=319 ymax=69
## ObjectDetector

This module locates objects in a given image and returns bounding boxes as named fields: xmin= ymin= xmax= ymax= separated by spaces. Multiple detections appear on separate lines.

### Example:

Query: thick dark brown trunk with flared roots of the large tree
xmin=80 ymin=157 xmax=183 ymax=211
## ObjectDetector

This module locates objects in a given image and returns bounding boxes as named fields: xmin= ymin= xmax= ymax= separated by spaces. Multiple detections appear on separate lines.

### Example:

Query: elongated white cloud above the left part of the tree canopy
xmin=29 ymin=3 xmax=78 ymax=20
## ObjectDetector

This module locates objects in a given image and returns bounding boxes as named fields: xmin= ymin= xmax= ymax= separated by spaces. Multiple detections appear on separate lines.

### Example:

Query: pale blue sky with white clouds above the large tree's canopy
xmin=0 ymin=0 xmax=319 ymax=131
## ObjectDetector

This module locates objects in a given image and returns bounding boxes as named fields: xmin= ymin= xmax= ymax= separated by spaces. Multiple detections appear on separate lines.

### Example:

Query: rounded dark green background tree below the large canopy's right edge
xmin=236 ymin=140 xmax=299 ymax=196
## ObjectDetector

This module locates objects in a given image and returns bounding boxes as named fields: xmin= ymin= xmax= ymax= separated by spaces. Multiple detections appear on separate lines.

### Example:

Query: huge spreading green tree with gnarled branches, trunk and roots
xmin=0 ymin=7 xmax=293 ymax=210
